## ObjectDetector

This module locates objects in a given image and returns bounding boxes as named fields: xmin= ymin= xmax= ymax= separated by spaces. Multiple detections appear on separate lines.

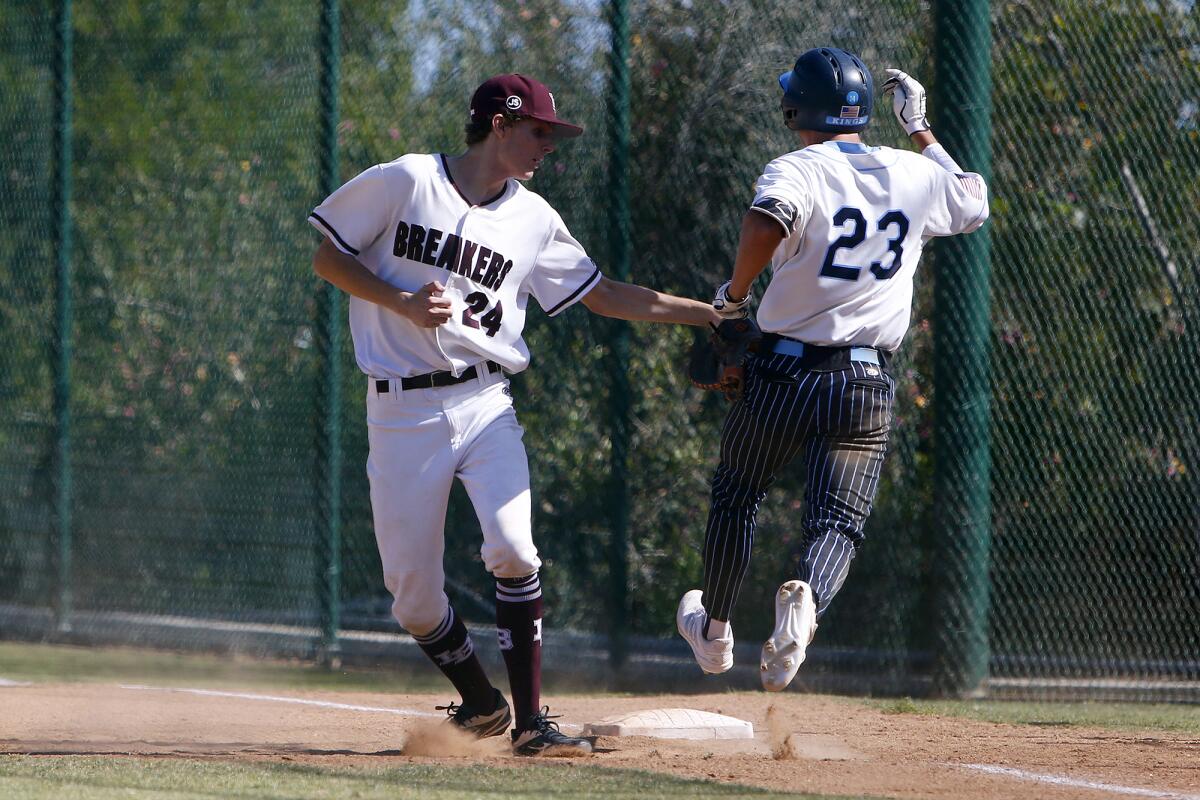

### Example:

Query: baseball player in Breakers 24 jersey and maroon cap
xmin=308 ymin=74 xmax=720 ymax=756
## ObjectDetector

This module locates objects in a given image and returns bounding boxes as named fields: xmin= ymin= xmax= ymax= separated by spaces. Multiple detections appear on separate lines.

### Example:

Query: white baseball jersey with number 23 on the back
xmin=752 ymin=142 xmax=989 ymax=350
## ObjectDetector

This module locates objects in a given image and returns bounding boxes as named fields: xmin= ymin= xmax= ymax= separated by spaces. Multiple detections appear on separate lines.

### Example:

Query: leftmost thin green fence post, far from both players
xmin=50 ymin=0 xmax=74 ymax=633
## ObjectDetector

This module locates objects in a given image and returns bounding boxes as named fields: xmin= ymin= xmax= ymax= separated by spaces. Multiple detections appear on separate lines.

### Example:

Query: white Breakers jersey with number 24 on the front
xmin=308 ymin=154 xmax=601 ymax=378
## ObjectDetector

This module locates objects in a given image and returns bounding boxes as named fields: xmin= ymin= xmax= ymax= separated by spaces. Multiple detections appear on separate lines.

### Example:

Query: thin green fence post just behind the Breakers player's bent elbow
xmin=313 ymin=0 xmax=342 ymax=667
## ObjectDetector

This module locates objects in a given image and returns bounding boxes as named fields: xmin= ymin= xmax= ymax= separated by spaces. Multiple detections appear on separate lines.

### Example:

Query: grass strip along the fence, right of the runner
xmin=866 ymin=697 xmax=1200 ymax=734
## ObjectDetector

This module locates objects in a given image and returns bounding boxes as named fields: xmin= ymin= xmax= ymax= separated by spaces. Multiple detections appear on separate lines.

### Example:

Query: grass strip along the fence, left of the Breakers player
xmin=0 ymin=642 xmax=446 ymax=692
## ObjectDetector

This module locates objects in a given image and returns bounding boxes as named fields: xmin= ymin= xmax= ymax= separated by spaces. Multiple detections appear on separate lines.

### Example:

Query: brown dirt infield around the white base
xmin=0 ymin=684 xmax=1200 ymax=800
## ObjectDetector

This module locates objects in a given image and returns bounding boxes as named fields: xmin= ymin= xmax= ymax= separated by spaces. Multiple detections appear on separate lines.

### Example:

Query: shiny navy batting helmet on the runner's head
xmin=779 ymin=47 xmax=875 ymax=133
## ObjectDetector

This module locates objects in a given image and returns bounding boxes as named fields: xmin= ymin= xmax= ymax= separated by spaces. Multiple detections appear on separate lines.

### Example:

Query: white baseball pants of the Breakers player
xmin=367 ymin=369 xmax=541 ymax=636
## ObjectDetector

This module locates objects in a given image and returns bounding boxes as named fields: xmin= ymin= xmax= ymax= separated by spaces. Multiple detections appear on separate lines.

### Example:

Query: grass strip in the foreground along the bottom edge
xmin=0 ymin=756 xmax=833 ymax=800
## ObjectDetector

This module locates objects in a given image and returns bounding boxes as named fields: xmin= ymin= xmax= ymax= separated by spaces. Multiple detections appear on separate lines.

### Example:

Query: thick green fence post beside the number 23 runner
xmin=930 ymin=0 xmax=991 ymax=697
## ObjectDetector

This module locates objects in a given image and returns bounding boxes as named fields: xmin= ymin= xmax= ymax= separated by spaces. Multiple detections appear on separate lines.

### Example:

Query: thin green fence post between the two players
xmin=608 ymin=0 xmax=632 ymax=667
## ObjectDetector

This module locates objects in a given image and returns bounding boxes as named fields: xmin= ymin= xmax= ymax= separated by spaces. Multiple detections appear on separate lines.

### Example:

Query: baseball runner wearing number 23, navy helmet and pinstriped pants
xmin=676 ymin=47 xmax=989 ymax=691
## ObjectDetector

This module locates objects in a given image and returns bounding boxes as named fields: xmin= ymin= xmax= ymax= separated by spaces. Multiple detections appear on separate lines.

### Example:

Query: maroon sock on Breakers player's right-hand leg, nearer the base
xmin=496 ymin=572 xmax=541 ymax=730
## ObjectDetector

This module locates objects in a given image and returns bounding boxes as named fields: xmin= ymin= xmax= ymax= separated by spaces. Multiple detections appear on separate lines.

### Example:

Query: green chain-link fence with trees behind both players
xmin=0 ymin=0 xmax=1200 ymax=700
